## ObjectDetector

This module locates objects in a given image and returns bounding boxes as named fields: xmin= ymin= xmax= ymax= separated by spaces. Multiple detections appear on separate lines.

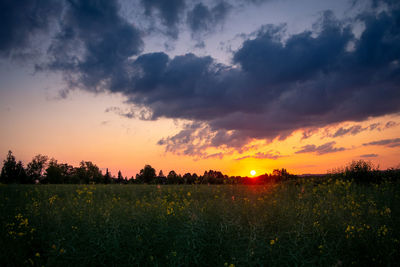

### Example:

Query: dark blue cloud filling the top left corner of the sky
xmin=0 ymin=0 xmax=62 ymax=57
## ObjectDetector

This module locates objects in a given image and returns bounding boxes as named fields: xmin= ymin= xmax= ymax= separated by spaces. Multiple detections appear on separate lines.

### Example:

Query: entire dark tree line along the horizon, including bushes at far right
xmin=0 ymin=151 xmax=400 ymax=184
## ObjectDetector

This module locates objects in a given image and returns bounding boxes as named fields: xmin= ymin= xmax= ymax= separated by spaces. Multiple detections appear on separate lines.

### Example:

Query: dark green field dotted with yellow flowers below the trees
xmin=0 ymin=179 xmax=400 ymax=267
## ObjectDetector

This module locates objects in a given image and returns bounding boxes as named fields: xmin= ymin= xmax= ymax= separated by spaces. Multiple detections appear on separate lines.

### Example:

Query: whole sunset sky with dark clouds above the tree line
xmin=0 ymin=0 xmax=400 ymax=177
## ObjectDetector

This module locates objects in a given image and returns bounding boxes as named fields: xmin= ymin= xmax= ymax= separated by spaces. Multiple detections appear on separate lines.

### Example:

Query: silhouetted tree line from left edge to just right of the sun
xmin=0 ymin=151 xmax=295 ymax=184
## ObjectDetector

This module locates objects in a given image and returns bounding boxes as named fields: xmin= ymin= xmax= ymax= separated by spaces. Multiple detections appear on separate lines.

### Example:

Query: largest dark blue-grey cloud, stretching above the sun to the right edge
xmin=100 ymin=4 xmax=400 ymax=157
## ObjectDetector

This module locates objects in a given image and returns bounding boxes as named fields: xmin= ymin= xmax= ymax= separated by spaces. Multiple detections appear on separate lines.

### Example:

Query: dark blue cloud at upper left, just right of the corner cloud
xmin=43 ymin=0 xmax=143 ymax=91
